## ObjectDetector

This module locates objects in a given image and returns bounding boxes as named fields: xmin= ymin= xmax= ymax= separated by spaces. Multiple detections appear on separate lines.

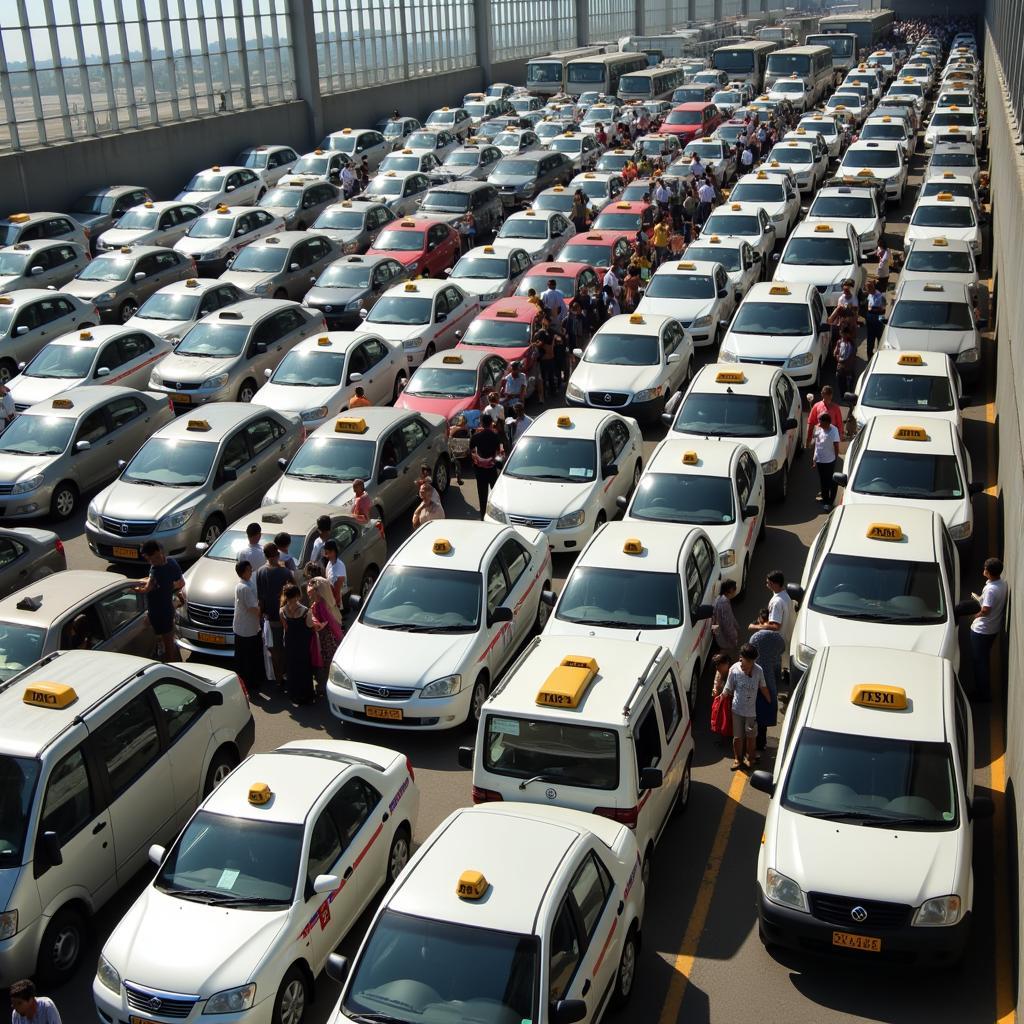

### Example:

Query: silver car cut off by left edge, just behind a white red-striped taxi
xmin=0 ymin=288 xmax=99 ymax=384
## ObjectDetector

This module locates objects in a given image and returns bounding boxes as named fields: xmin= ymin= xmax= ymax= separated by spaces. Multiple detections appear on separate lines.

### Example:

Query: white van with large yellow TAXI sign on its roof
xmin=459 ymin=636 xmax=693 ymax=888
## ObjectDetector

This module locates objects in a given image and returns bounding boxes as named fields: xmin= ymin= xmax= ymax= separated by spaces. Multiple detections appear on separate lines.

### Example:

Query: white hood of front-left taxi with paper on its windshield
xmin=103 ymin=887 xmax=291 ymax=996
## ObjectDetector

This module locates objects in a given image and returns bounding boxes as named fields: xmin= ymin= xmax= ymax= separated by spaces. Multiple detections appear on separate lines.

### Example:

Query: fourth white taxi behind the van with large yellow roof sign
xmin=718 ymin=281 xmax=831 ymax=387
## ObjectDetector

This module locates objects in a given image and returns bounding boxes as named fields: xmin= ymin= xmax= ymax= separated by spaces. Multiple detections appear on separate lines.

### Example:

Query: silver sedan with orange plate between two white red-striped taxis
xmin=150 ymin=299 xmax=327 ymax=412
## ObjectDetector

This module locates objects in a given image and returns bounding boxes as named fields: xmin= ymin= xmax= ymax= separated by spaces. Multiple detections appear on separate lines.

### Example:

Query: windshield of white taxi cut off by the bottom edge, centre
xmin=341 ymin=913 xmax=538 ymax=1024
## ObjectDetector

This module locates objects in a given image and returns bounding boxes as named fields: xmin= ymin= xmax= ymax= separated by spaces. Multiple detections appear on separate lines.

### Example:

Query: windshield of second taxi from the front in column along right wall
xmin=809 ymin=542 xmax=946 ymax=625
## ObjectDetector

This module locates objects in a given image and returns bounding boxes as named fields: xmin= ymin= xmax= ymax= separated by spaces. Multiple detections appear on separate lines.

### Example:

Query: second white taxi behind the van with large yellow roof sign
xmin=618 ymin=434 xmax=767 ymax=596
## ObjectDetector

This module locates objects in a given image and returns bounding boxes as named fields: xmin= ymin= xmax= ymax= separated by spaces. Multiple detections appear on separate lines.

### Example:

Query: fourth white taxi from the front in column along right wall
xmin=844 ymin=348 xmax=970 ymax=430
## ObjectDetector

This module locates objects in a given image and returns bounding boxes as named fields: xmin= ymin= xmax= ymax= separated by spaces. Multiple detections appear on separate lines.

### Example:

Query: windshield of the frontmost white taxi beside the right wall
xmin=782 ymin=729 xmax=958 ymax=831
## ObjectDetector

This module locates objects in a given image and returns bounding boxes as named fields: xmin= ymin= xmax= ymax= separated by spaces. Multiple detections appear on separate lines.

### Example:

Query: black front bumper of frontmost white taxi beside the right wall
xmin=757 ymin=885 xmax=971 ymax=965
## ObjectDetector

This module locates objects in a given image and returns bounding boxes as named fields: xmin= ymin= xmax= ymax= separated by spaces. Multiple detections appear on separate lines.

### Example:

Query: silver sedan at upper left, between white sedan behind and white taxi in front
xmin=65 ymin=246 xmax=197 ymax=324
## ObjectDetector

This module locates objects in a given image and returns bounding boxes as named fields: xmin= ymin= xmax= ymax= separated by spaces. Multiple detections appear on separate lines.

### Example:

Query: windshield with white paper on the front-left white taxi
xmin=153 ymin=811 xmax=302 ymax=909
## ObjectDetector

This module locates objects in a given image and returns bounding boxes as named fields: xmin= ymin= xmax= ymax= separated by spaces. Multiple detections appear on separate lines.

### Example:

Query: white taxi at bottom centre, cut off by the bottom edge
xmin=328 ymin=802 xmax=644 ymax=1024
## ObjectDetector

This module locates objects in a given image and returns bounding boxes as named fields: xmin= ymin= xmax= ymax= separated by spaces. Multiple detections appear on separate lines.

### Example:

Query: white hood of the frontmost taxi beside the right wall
xmin=765 ymin=807 xmax=967 ymax=905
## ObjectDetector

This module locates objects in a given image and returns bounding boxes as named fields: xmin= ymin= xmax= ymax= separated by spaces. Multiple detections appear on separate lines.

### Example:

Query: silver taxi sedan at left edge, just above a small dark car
xmin=0 ymin=384 xmax=174 ymax=520
